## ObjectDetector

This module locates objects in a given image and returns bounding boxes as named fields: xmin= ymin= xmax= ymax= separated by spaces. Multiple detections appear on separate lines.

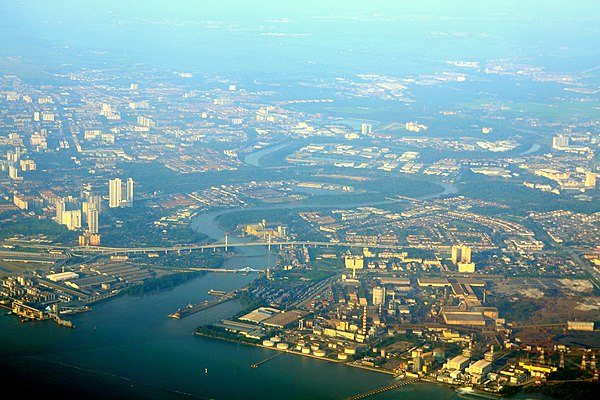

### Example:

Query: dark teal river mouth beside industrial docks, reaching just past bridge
xmin=0 ymin=183 xmax=548 ymax=399
